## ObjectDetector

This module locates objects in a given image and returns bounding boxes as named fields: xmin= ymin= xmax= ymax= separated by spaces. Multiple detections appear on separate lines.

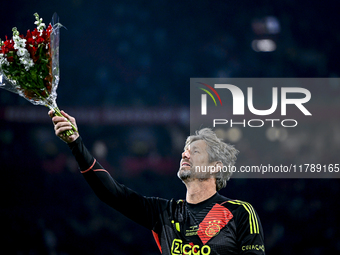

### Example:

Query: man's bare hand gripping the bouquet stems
xmin=48 ymin=110 xmax=79 ymax=143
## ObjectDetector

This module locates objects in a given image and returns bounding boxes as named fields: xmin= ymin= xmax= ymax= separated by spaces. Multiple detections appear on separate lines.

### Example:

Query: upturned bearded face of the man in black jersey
xmin=177 ymin=140 xmax=212 ymax=181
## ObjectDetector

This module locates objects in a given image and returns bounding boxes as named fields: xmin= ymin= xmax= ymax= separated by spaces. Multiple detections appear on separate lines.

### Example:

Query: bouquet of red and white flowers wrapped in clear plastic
xmin=0 ymin=13 xmax=77 ymax=135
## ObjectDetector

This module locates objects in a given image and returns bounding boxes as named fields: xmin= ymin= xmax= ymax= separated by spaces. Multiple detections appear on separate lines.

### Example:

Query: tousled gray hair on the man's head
xmin=184 ymin=128 xmax=239 ymax=190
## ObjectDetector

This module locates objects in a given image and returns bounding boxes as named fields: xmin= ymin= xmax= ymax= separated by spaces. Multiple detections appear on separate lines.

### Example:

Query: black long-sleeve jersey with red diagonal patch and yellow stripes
xmin=69 ymin=137 xmax=265 ymax=255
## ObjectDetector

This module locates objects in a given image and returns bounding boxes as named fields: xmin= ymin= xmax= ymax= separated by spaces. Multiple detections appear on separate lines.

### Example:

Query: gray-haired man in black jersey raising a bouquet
xmin=49 ymin=111 xmax=264 ymax=255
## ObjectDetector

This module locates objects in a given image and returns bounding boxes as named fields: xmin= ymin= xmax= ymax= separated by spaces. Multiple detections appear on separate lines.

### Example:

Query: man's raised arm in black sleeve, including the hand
xmin=48 ymin=111 xmax=168 ymax=230
